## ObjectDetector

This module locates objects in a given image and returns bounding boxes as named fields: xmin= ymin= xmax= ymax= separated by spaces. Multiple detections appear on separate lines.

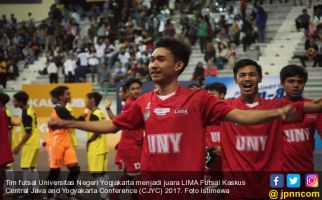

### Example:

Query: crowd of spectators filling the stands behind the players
xmin=0 ymin=0 xmax=310 ymax=87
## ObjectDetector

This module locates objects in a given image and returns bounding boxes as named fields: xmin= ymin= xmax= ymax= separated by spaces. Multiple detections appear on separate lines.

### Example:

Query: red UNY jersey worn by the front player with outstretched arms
xmin=113 ymin=86 xmax=232 ymax=172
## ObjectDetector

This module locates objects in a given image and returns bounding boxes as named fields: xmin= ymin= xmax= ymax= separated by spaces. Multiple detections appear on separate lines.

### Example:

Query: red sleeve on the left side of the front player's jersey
xmin=112 ymin=99 xmax=144 ymax=130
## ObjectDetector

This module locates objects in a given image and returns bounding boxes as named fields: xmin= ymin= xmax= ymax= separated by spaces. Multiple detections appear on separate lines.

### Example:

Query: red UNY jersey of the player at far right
xmin=283 ymin=98 xmax=322 ymax=172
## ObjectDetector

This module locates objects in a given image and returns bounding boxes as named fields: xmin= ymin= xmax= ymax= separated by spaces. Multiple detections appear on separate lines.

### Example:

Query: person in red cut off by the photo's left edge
xmin=0 ymin=93 xmax=13 ymax=200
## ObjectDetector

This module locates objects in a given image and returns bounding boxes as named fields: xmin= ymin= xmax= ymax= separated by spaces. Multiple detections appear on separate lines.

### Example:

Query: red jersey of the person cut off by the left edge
xmin=0 ymin=109 xmax=13 ymax=166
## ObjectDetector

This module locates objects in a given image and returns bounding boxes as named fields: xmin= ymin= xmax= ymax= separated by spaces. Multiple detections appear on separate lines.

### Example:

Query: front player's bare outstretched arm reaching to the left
xmin=48 ymin=120 xmax=120 ymax=134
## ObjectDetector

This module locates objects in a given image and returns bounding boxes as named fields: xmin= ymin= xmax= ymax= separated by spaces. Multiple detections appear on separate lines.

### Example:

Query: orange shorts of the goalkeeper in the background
xmin=46 ymin=144 xmax=78 ymax=169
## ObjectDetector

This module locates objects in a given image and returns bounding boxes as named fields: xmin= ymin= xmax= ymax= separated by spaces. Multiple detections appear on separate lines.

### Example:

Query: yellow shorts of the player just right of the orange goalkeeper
xmin=87 ymin=153 xmax=108 ymax=173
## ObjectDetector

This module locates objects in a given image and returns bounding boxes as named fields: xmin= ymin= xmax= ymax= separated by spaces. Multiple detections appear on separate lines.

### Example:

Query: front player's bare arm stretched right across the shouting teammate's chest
xmin=223 ymin=105 xmax=296 ymax=125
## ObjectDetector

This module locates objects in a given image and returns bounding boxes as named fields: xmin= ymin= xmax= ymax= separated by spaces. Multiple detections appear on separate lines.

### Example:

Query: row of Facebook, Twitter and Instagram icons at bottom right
xmin=270 ymin=174 xmax=319 ymax=188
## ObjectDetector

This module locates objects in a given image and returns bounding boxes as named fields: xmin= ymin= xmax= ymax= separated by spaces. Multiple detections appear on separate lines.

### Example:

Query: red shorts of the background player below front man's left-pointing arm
xmin=115 ymin=145 xmax=141 ymax=175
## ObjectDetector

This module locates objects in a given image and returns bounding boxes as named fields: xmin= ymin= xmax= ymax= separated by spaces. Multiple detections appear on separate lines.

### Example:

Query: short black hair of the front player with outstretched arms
xmin=154 ymin=37 xmax=192 ymax=74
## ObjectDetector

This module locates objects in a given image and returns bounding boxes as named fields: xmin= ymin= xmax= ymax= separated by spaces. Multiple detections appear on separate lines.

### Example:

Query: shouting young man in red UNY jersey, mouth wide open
xmin=220 ymin=59 xmax=321 ymax=199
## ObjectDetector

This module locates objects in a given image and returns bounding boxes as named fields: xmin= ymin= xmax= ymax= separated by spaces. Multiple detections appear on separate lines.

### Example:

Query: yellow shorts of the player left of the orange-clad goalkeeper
xmin=20 ymin=148 xmax=39 ymax=169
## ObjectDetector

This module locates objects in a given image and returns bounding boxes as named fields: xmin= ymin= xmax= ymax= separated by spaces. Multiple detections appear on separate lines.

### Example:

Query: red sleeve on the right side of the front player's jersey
xmin=201 ymin=93 xmax=233 ymax=125
